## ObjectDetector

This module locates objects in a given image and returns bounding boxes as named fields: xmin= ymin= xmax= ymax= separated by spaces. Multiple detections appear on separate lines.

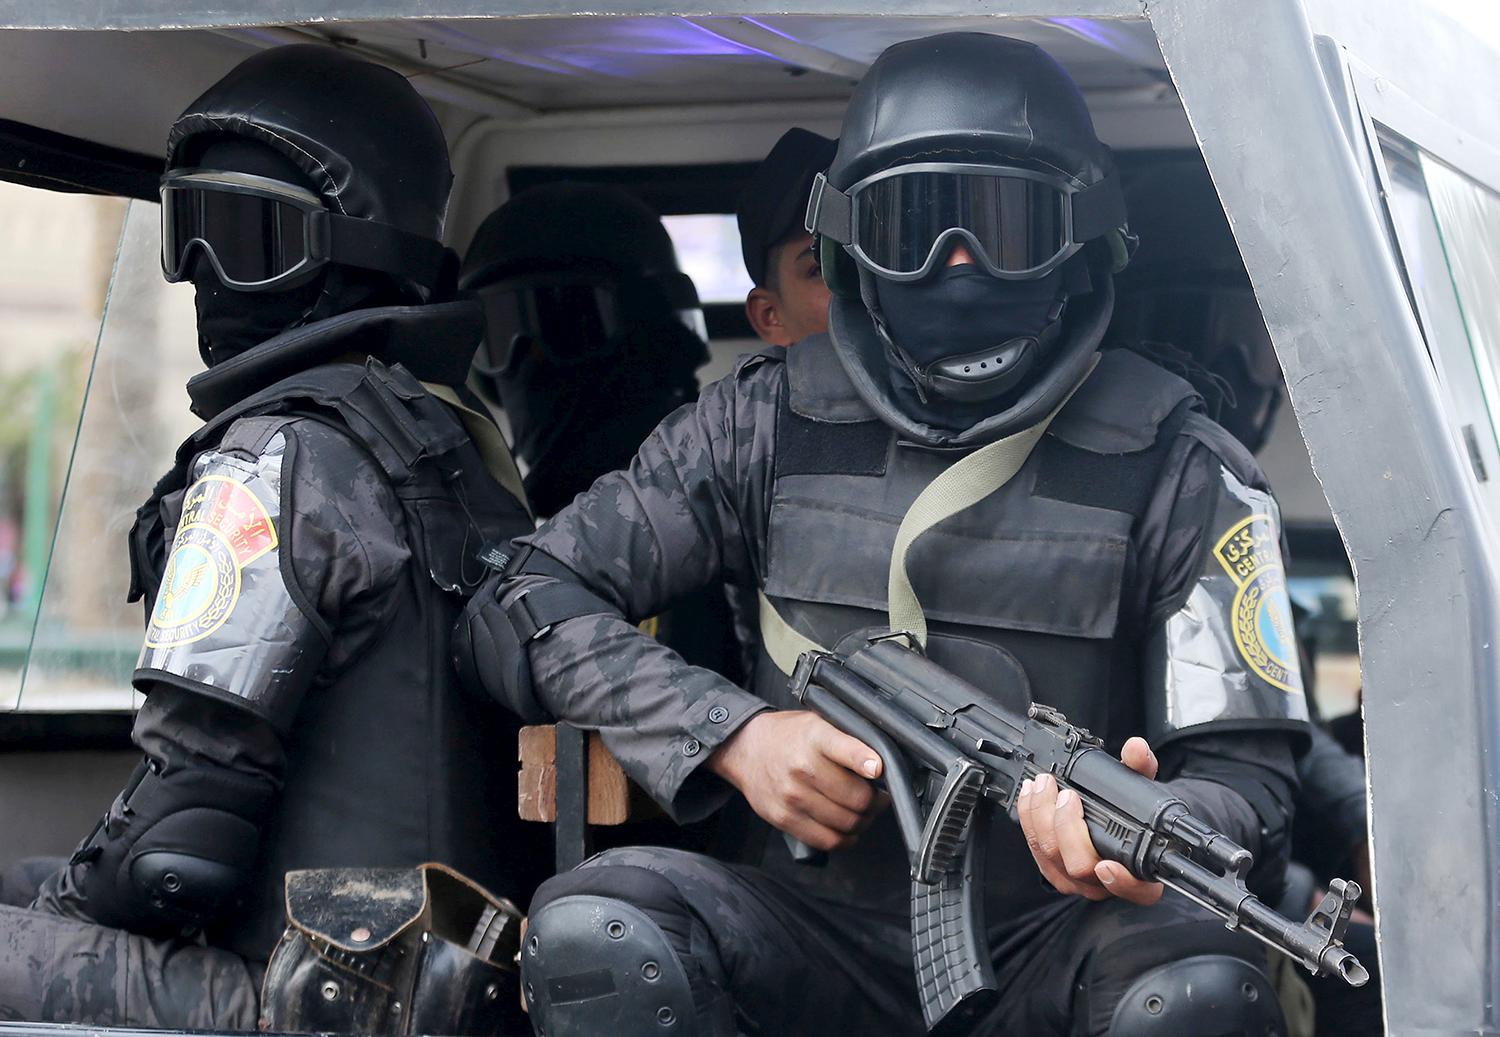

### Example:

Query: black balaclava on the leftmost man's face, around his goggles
xmin=189 ymin=137 xmax=327 ymax=368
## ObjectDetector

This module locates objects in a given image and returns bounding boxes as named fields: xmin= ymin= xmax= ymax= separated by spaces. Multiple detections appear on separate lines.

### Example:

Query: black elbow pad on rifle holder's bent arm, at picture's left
xmin=453 ymin=548 xmax=620 ymax=723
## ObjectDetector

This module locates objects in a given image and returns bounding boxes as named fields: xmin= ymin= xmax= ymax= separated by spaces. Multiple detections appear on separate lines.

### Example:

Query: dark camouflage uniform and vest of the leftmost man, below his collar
xmin=0 ymin=358 xmax=545 ymax=1029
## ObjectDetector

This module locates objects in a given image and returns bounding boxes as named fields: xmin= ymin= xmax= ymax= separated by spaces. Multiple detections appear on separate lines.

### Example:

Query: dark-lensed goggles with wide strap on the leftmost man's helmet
xmin=161 ymin=170 xmax=444 ymax=291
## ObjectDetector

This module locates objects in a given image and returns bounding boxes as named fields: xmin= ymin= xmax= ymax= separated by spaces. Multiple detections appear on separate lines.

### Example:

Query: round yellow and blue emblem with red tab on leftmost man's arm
xmin=146 ymin=476 xmax=278 ymax=648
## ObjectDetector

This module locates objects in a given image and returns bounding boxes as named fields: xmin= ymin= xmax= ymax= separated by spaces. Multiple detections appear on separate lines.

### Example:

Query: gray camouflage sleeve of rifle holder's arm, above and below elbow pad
xmin=510 ymin=357 xmax=785 ymax=821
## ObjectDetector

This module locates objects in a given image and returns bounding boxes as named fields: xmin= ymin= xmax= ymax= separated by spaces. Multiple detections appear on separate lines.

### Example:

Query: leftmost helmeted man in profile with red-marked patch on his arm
xmin=0 ymin=47 xmax=548 ymax=1032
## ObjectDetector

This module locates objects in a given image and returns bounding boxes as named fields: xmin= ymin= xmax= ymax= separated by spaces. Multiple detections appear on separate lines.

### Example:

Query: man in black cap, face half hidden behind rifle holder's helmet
xmin=735 ymin=128 xmax=837 ymax=345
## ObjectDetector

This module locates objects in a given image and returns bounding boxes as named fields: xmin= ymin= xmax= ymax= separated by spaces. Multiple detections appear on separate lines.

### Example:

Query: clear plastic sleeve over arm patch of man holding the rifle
xmin=1145 ymin=468 xmax=1308 ymax=744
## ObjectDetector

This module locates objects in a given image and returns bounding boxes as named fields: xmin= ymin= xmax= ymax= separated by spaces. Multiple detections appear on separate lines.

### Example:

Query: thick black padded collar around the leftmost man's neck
xmin=188 ymin=299 xmax=485 ymax=422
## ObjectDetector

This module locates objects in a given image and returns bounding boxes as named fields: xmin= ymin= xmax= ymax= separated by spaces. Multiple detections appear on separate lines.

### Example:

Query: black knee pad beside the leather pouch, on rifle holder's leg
xmin=521 ymin=896 xmax=701 ymax=1037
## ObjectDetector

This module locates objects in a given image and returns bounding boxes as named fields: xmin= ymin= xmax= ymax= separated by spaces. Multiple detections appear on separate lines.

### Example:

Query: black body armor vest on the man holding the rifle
xmin=752 ymin=339 xmax=1197 ymax=917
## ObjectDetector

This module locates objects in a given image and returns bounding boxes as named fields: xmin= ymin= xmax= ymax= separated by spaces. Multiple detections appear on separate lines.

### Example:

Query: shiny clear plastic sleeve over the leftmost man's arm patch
xmin=135 ymin=432 xmax=323 ymax=728
